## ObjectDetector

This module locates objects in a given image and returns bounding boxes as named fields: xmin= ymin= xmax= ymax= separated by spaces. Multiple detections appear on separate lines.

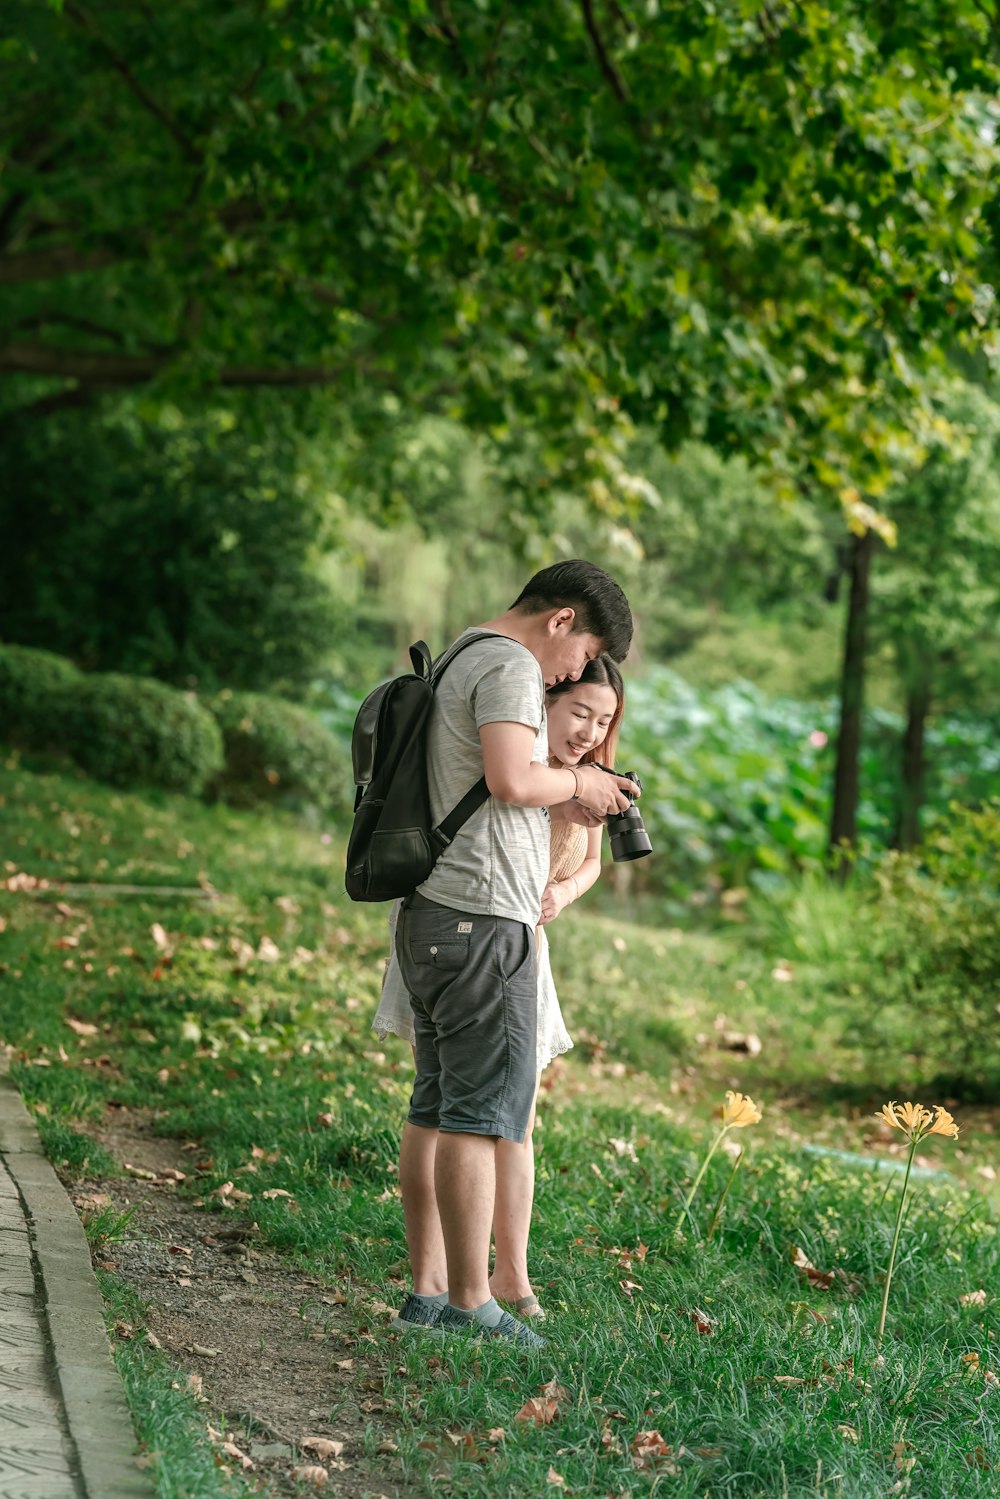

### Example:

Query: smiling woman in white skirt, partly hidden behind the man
xmin=372 ymin=655 xmax=625 ymax=1318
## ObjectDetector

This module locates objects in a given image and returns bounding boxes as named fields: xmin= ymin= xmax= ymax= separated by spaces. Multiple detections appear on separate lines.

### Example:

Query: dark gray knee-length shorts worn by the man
xmin=396 ymin=895 xmax=538 ymax=1144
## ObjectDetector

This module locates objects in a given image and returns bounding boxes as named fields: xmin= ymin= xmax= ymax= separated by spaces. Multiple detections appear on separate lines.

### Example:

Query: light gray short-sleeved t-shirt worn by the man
xmin=420 ymin=630 xmax=549 ymax=926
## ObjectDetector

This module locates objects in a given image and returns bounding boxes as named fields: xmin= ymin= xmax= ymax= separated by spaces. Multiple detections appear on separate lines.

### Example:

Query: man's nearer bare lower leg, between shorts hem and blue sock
xmin=434 ymin=1133 xmax=496 ymax=1312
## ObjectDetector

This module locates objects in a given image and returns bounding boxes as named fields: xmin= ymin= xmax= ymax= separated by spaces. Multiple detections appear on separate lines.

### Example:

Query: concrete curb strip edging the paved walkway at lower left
xmin=0 ymin=1054 xmax=154 ymax=1499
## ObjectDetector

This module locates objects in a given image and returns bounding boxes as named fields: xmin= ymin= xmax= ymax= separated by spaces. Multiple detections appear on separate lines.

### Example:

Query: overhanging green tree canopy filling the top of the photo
xmin=0 ymin=0 xmax=997 ymax=506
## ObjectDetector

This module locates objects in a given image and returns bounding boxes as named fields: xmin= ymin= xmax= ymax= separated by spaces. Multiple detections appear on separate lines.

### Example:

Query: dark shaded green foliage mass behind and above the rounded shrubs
xmin=0 ymin=399 xmax=339 ymax=696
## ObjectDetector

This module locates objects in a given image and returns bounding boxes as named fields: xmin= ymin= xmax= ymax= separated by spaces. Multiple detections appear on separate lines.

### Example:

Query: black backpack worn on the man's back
xmin=345 ymin=631 xmax=498 ymax=901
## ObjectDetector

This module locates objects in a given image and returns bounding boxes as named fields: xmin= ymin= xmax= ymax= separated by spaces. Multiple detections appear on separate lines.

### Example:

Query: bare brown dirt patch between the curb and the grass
xmin=57 ymin=1109 xmax=423 ymax=1499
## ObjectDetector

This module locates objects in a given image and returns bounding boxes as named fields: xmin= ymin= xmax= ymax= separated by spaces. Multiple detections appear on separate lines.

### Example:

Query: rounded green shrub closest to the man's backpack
xmin=208 ymin=691 xmax=352 ymax=809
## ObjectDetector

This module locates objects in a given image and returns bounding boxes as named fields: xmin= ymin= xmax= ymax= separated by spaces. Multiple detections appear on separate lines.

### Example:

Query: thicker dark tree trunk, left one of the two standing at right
xmin=829 ymin=531 xmax=876 ymax=881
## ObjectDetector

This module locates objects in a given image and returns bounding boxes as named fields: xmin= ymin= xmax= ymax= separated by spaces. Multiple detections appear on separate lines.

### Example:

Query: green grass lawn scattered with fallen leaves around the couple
xmin=0 ymin=761 xmax=1000 ymax=1499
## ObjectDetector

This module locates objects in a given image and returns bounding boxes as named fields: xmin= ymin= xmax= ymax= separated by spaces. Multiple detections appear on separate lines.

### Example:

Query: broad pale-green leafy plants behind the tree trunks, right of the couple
xmin=618 ymin=667 xmax=1000 ymax=901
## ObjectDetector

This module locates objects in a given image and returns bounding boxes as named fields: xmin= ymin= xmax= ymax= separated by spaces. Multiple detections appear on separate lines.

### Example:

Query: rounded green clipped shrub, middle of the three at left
xmin=61 ymin=672 xmax=222 ymax=794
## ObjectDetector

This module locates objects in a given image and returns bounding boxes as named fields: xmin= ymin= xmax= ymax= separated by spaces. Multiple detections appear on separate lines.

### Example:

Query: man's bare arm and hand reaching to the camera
xmin=480 ymin=724 xmax=636 ymax=817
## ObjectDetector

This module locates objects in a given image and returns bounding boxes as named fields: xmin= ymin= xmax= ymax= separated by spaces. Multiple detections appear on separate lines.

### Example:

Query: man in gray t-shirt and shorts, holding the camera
xmin=394 ymin=561 xmax=634 ymax=1346
